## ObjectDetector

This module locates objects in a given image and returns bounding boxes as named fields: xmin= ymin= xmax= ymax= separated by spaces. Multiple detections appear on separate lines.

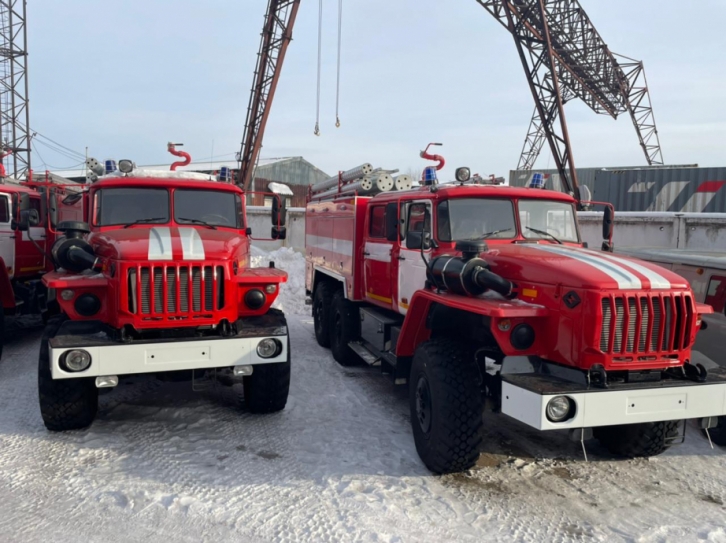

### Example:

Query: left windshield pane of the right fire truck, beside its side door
xmin=437 ymin=198 xmax=517 ymax=241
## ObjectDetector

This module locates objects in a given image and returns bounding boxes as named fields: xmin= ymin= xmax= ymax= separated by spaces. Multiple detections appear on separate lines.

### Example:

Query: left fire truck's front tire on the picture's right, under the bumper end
xmin=242 ymin=338 xmax=290 ymax=414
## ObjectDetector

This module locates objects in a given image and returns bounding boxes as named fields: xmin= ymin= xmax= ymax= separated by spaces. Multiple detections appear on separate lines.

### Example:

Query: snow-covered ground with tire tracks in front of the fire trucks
xmin=0 ymin=316 xmax=726 ymax=542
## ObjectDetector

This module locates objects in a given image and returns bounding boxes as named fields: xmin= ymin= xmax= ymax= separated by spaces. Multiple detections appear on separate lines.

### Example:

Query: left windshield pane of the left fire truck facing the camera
xmin=94 ymin=188 xmax=169 ymax=226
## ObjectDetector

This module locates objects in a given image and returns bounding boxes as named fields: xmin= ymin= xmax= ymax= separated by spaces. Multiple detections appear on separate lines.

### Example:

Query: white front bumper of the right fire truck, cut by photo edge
xmin=502 ymin=381 xmax=726 ymax=430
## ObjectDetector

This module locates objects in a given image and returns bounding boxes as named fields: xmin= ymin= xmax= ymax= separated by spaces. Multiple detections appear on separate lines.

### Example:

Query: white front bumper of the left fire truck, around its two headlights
xmin=50 ymin=336 xmax=288 ymax=379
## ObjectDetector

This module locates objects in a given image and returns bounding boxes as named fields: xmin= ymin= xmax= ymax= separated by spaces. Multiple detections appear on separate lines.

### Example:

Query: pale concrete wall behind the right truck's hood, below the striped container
xmin=578 ymin=211 xmax=726 ymax=251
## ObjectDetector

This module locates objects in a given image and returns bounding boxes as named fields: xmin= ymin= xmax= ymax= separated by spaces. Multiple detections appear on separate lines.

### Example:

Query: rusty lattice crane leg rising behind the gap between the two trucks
xmin=238 ymin=0 xmax=300 ymax=190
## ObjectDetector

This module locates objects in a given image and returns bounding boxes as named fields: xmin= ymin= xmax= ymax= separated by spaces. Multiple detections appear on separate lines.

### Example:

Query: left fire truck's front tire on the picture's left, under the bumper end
xmin=38 ymin=316 xmax=98 ymax=432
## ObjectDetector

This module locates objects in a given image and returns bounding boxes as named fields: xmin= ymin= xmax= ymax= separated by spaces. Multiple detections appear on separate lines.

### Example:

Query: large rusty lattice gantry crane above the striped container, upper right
xmin=476 ymin=0 xmax=663 ymax=200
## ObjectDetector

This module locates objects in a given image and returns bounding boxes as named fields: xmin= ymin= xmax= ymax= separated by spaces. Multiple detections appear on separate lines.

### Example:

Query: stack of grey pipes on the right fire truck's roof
xmin=311 ymin=163 xmax=413 ymax=199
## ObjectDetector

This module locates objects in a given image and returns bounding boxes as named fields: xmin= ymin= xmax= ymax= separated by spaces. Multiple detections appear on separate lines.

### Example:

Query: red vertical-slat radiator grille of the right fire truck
xmin=600 ymin=294 xmax=693 ymax=354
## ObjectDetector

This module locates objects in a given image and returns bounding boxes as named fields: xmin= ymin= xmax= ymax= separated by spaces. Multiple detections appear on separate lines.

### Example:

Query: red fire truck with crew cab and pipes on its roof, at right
xmin=306 ymin=165 xmax=726 ymax=473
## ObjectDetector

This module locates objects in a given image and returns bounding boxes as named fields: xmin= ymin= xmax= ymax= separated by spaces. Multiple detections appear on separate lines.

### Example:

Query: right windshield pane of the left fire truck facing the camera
xmin=174 ymin=189 xmax=242 ymax=228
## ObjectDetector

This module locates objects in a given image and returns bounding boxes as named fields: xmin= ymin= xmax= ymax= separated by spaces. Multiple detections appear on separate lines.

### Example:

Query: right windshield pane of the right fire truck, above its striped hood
xmin=519 ymin=200 xmax=580 ymax=242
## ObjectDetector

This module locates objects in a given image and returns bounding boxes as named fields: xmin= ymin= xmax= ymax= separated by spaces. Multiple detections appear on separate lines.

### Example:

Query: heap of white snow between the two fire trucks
xmin=250 ymin=247 xmax=310 ymax=315
